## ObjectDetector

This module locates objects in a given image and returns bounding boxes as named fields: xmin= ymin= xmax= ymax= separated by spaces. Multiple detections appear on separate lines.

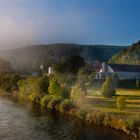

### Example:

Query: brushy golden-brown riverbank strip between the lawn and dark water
xmin=41 ymin=97 xmax=140 ymax=138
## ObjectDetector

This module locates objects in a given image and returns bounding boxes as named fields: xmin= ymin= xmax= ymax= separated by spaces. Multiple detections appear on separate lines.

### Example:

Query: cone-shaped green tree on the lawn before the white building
xmin=101 ymin=77 xmax=116 ymax=97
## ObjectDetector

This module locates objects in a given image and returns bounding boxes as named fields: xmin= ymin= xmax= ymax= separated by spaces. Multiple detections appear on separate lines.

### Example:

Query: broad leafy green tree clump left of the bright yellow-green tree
xmin=18 ymin=77 xmax=49 ymax=102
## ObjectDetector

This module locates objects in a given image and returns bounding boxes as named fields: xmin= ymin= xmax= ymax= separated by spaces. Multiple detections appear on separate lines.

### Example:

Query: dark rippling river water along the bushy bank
xmin=0 ymin=97 xmax=136 ymax=140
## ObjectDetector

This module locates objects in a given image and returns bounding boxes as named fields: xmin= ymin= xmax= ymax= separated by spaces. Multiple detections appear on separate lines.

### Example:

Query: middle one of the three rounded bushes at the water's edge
xmin=48 ymin=97 xmax=62 ymax=109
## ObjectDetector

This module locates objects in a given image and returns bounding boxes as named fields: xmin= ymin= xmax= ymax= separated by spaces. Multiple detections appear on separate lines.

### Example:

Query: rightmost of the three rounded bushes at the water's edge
xmin=60 ymin=99 xmax=74 ymax=112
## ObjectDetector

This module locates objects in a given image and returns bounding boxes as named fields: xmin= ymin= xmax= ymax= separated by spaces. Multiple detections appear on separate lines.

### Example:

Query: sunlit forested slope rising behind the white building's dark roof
xmin=109 ymin=41 xmax=140 ymax=64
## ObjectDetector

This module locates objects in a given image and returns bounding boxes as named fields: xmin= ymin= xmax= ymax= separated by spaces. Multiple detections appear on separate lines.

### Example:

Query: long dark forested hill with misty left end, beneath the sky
xmin=0 ymin=44 xmax=123 ymax=70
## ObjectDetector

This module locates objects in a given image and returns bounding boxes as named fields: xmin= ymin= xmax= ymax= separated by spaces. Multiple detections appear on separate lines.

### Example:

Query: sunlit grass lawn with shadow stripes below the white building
xmin=85 ymin=88 xmax=140 ymax=114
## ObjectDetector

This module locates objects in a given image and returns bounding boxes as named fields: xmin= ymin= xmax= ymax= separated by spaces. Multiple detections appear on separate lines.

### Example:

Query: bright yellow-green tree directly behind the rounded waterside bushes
xmin=48 ymin=77 xmax=63 ymax=97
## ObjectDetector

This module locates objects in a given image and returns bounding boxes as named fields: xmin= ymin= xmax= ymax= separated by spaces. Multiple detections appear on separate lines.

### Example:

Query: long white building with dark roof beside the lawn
xmin=95 ymin=62 xmax=140 ymax=79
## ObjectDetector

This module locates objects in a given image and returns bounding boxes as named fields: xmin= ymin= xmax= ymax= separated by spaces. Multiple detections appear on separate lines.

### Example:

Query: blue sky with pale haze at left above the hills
xmin=0 ymin=0 xmax=140 ymax=49
